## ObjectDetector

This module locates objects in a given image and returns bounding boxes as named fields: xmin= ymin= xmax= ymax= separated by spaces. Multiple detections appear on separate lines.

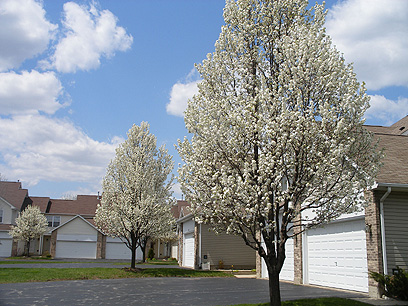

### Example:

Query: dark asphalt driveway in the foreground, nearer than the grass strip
xmin=0 ymin=278 xmax=364 ymax=306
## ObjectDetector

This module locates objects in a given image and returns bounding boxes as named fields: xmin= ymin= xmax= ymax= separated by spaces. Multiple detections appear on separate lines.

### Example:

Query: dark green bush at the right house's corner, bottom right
xmin=370 ymin=267 xmax=408 ymax=301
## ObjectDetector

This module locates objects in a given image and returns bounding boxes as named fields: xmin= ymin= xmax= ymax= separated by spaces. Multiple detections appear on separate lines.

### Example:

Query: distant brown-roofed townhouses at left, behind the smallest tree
xmin=0 ymin=182 xmax=142 ymax=260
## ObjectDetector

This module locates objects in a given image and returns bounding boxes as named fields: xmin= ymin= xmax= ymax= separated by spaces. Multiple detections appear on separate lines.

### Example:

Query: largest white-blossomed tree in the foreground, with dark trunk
xmin=178 ymin=0 xmax=381 ymax=305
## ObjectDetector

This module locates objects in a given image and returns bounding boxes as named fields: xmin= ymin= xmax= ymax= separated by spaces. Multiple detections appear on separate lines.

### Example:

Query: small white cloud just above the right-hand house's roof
xmin=365 ymin=95 xmax=408 ymax=125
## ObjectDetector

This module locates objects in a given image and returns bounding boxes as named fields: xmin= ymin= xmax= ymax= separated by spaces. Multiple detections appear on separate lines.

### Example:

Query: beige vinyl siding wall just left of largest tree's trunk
xmin=201 ymin=224 xmax=256 ymax=269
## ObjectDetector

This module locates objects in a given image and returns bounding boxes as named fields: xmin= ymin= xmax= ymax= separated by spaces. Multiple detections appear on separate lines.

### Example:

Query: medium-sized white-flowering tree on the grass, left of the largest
xmin=95 ymin=122 xmax=174 ymax=268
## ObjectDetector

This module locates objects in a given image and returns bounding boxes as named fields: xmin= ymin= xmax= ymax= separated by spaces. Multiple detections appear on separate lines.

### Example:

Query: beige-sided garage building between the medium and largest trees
xmin=177 ymin=202 xmax=256 ymax=270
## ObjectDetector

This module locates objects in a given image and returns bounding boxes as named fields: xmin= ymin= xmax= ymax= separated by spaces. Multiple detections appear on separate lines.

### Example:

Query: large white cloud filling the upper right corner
xmin=326 ymin=0 xmax=408 ymax=90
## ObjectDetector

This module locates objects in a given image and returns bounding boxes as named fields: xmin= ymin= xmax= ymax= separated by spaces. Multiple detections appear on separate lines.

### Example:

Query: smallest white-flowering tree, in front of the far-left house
xmin=9 ymin=206 xmax=48 ymax=256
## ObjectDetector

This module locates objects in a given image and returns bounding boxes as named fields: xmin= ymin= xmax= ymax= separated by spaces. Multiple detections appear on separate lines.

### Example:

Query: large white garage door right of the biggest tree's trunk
xmin=305 ymin=219 xmax=368 ymax=292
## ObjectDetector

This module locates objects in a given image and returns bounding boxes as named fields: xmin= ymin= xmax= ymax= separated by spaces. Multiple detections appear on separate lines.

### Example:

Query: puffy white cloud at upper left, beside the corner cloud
xmin=42 ymin=2 xmax=133 ymax=73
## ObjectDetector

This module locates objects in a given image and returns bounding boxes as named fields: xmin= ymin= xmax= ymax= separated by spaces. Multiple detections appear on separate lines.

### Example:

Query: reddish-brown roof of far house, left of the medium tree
xmin=48 ymin=195 xmax=101 ymax=216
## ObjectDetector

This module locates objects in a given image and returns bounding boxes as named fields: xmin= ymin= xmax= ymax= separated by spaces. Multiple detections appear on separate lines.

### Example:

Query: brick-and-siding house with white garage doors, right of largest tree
xmin=257 ymin=117 xmax=408 ymax=297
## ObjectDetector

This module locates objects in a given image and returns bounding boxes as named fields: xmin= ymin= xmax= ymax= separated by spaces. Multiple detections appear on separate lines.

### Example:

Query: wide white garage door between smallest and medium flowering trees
xmin=55 ymin=241 xmax=96 ymax=259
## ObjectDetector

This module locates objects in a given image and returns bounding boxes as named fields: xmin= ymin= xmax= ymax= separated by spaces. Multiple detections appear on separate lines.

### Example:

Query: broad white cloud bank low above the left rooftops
xmin=0 ymin=114 xmax=123 ymax=186
